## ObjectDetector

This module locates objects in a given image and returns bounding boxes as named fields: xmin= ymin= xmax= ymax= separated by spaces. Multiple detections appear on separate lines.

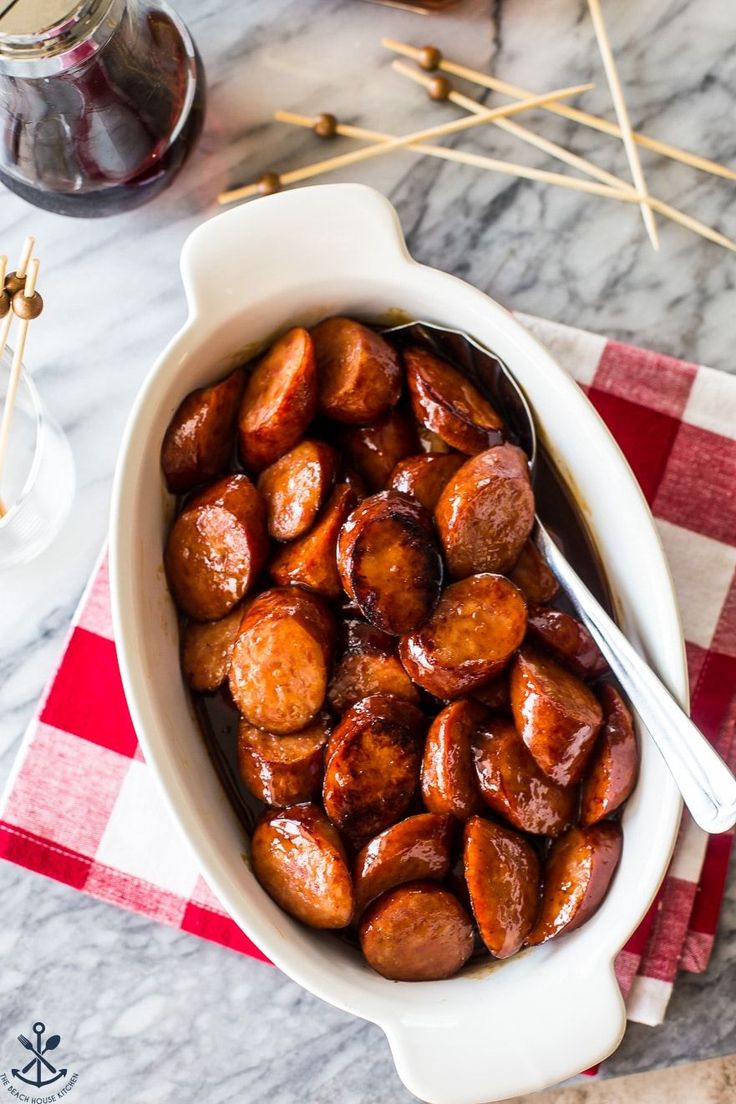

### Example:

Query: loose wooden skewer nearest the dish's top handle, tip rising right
xmin=217 ymin=84 xmax=591 ymax=203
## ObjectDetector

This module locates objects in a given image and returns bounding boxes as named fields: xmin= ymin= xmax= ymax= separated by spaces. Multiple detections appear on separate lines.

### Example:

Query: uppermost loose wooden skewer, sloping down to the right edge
xmin=381 ymin=39 xmax=736 ymax=180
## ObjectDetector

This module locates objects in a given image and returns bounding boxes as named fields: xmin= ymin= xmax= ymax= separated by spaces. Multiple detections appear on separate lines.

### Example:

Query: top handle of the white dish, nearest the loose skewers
xmin=176 ymin=184 xmax=410 ymax=323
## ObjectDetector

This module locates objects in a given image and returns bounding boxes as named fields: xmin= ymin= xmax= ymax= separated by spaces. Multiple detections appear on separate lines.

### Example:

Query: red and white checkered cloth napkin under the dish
xmin=0 ymin=318 xmax=736 ymax=1023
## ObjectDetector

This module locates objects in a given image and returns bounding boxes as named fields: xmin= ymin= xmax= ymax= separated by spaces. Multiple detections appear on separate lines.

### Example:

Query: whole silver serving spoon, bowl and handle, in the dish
xmin=384 ymin=322 xmax=736 ymax=832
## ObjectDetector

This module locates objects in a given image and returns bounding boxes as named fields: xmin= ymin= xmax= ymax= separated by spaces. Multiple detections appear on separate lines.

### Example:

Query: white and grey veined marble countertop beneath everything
xmin=0 ymin=0 xmax=736 ymax=1104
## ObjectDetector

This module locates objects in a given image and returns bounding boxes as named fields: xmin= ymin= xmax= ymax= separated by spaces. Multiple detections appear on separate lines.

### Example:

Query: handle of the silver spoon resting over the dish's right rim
xmin=535 ymin=519 xmax=736 ymax=832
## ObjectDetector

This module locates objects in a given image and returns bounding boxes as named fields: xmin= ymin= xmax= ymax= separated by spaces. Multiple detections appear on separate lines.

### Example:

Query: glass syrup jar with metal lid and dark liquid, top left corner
xmin=0 ymin=0 xmax=204 ymax=216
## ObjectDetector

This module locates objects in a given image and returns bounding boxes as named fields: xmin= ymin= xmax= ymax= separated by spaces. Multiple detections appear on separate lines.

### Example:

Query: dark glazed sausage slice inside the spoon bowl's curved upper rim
xmin=403 ymin=346 xmax=503 ymax=456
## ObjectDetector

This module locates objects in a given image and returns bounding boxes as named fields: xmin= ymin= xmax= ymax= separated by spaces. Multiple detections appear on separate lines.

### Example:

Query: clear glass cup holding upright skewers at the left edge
xmin=0 ymin=350 xmax=75 ymax=571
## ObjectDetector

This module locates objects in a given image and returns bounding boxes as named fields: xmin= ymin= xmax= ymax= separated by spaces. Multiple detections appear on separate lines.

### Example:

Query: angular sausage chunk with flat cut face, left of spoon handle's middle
xmin=511 ymin=648 xmax=602 ymax=786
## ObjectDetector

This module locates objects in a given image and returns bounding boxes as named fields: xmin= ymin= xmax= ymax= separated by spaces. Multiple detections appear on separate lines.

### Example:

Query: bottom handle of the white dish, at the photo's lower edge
xmin=382 ymin=963 xmax=626 ymax=1104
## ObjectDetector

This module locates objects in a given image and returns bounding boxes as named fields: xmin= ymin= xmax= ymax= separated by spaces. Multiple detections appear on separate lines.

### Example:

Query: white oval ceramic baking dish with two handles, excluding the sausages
xmin=110 ymin=184 xmax=687 ymax=1104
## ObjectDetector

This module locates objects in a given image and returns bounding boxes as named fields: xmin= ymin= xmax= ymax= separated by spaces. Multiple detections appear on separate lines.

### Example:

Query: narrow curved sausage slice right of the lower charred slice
xmin=422 ymin=699 xmax=487 ymax=820
